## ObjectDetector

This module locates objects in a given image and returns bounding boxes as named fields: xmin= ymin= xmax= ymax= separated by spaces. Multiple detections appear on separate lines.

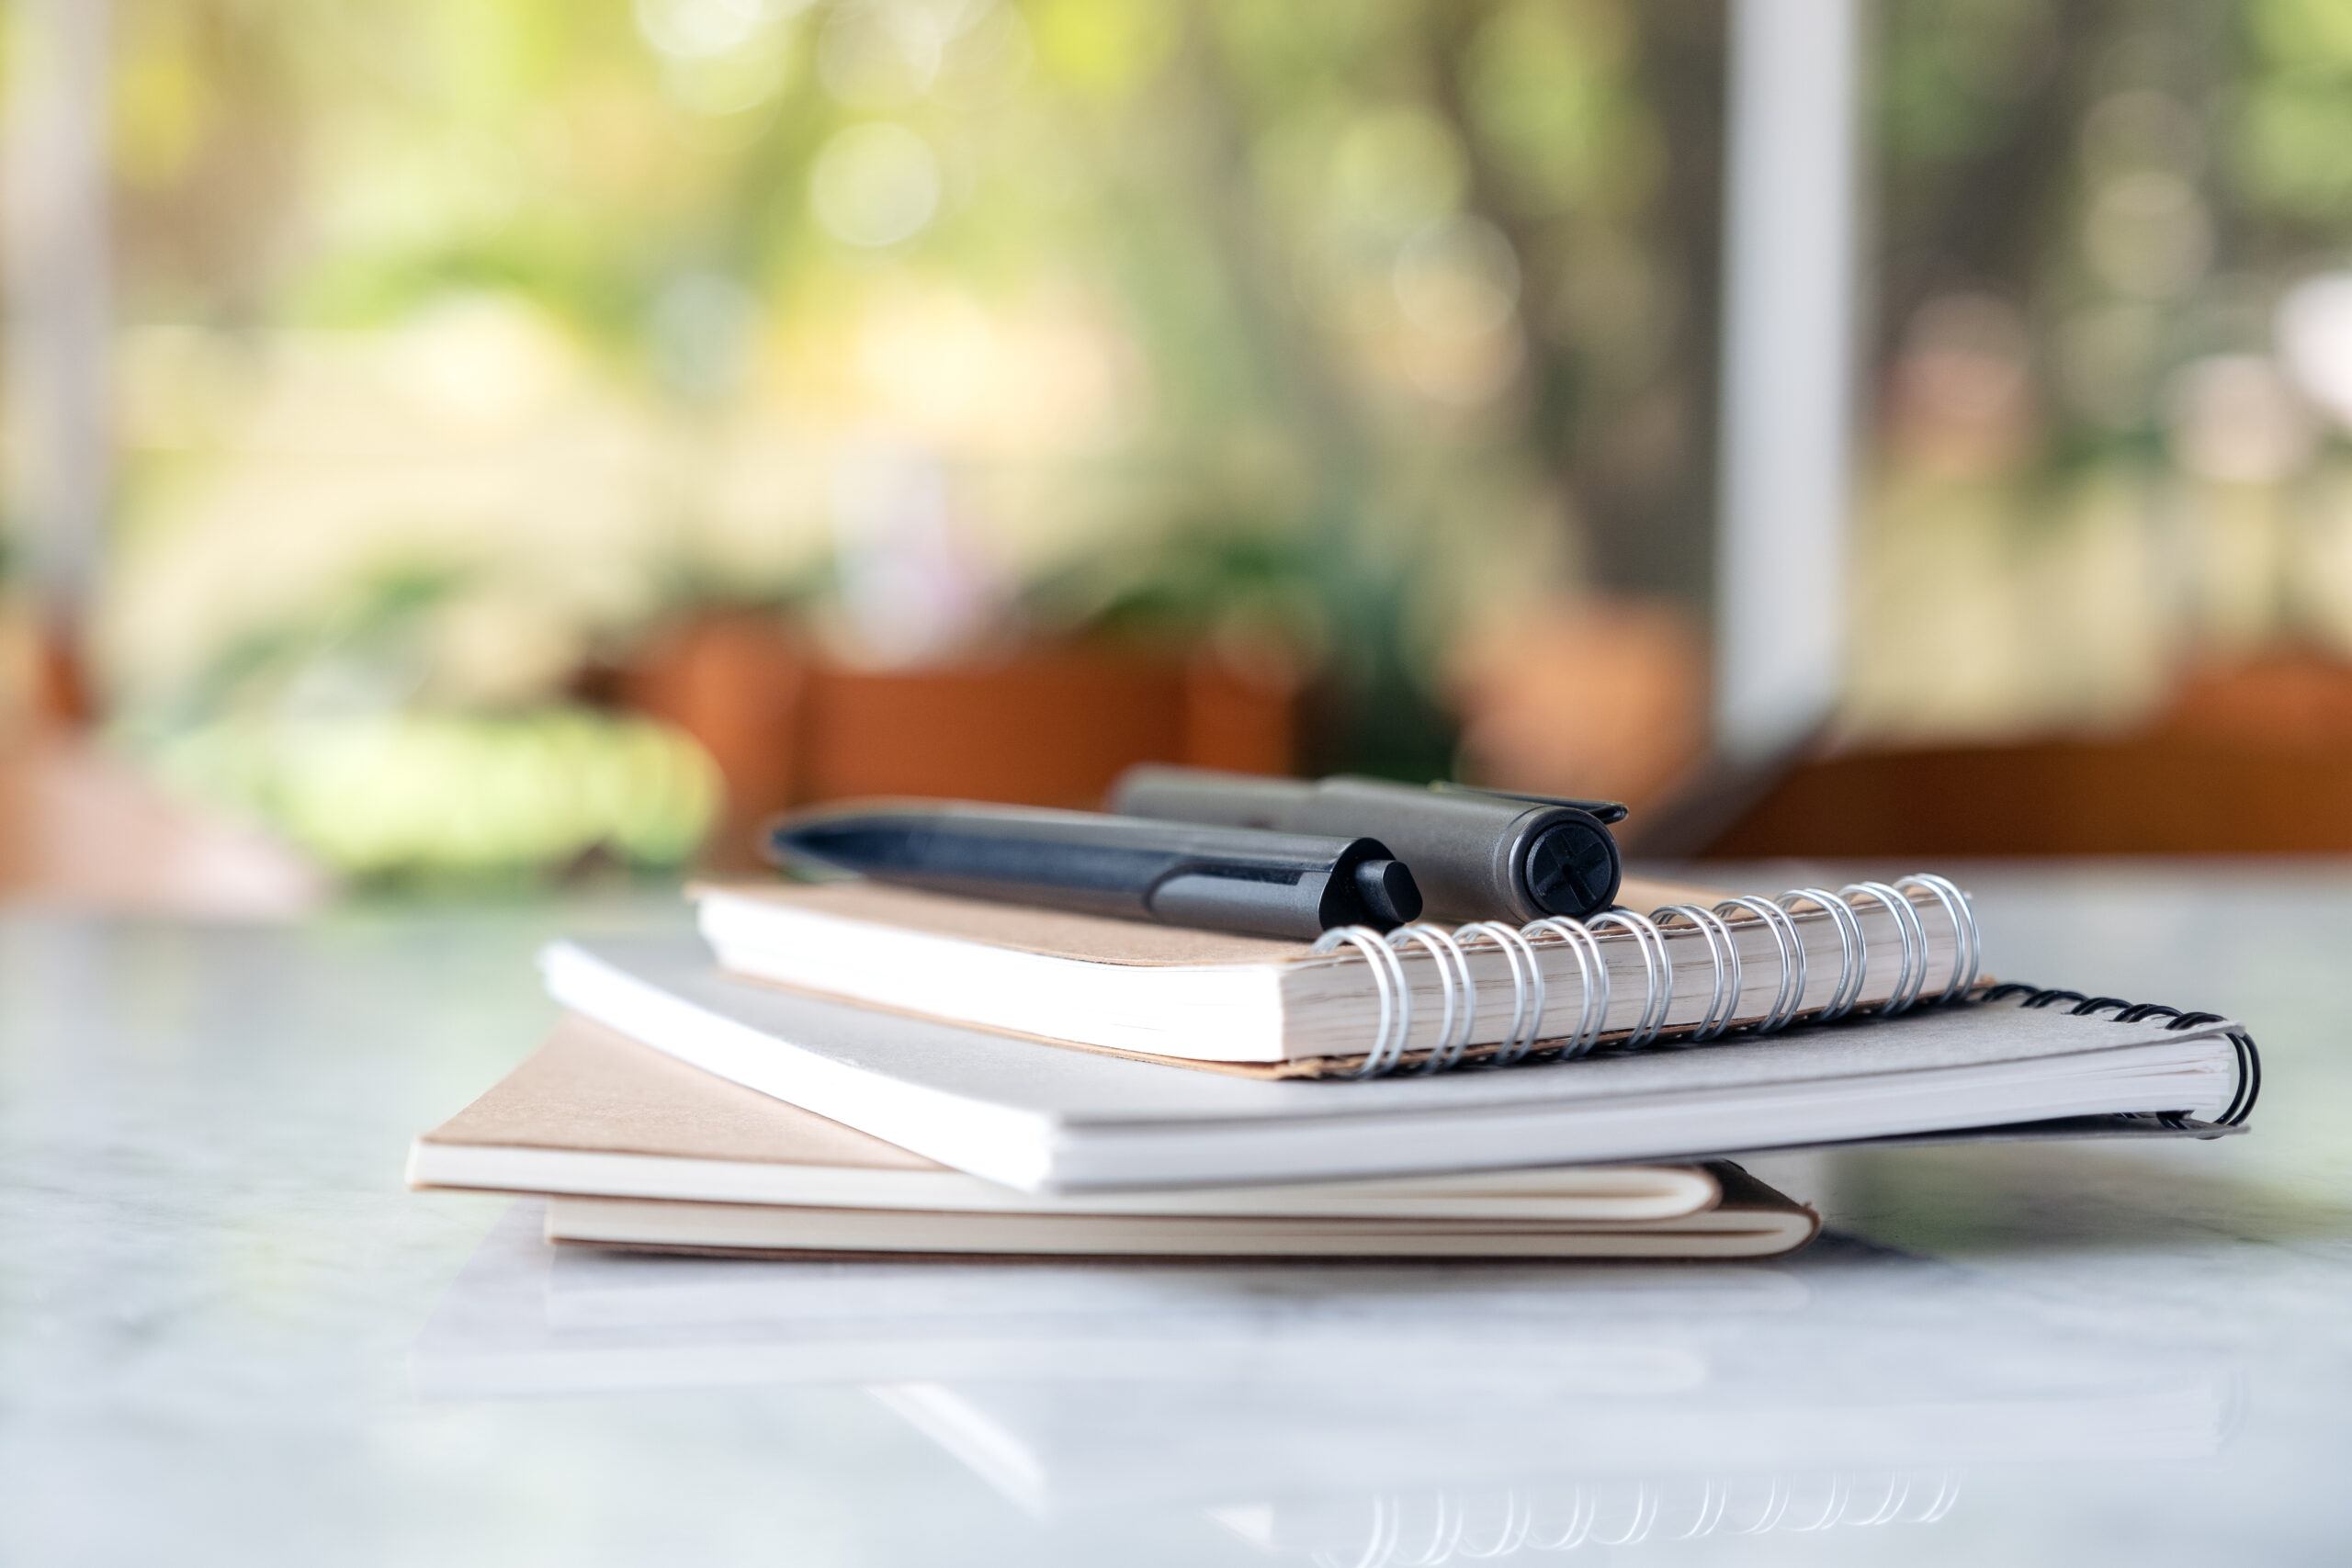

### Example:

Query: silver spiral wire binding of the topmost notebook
xmin=1310 ymin=874 xmax=1984 ymax=1079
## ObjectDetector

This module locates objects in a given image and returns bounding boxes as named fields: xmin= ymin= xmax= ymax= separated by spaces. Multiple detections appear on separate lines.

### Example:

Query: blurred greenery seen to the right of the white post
xmin=1851 ymin=0 xmax=2352 ymax=739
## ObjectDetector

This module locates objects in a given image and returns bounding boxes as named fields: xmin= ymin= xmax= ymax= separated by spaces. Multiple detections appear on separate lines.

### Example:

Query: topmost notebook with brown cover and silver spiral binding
xmin=696 ymin=874 xmax=1978 ymax=1077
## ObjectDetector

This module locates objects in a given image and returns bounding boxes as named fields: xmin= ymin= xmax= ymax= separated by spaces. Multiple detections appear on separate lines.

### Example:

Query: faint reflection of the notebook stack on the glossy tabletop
xmin=412 ymin=1201 xmax=2234 ymax=1568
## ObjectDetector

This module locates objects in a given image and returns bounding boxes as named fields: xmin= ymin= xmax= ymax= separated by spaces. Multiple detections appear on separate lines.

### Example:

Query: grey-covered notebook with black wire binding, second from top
xmin=541 ymin=938 xmax=2256 ymax=1192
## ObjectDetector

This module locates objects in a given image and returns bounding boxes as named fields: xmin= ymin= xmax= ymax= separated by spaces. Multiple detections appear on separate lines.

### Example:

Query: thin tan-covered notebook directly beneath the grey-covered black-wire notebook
xmin=409 ymin=1018 xmax=1731 ymax=1253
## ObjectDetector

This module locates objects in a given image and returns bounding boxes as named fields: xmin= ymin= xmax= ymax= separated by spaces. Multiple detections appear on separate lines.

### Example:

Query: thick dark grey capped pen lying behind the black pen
xmin=1105 ymin=761 xmax=1625 ymax=921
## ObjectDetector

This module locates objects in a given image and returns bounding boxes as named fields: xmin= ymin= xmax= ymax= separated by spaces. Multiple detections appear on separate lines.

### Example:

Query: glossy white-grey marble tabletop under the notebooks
xmin=0 ymin=863 xmax=2352 ymax=1568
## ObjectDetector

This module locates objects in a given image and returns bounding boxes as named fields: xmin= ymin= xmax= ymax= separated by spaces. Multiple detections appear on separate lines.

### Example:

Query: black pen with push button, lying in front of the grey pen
xmin=767 ymin=799 xmax=1420 ymax=941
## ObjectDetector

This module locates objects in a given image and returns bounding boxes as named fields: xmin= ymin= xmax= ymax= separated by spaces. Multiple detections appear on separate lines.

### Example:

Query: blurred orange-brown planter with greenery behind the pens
xmin=591 ymin=534 xmax=1315 ymax=867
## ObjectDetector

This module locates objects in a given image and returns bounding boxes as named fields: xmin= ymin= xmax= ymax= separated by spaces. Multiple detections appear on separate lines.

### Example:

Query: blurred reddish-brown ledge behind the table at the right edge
xmin=1702 ymin=651 xmax=2352 ymax=858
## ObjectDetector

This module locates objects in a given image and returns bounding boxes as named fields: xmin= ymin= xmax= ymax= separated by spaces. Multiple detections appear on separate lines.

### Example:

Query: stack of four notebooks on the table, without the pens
xmin=409 ymin=877 xmax=2258 ymax=1258
